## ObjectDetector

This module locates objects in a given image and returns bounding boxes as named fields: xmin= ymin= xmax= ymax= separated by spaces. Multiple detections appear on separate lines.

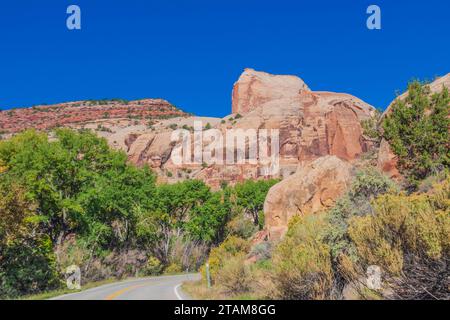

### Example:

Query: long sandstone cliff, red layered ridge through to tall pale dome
xmin=0 ymin=69 xmax=374 ymax=188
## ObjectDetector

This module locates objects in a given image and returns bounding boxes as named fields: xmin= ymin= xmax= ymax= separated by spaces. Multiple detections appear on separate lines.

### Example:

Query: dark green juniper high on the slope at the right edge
xmin=383 ymin=81 xmax=450 ymax=186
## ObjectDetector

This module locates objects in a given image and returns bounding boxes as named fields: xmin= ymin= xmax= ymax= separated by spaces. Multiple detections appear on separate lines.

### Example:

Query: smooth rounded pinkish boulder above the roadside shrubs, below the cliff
xmin=264 ymin=156 xmax=352 ymax=239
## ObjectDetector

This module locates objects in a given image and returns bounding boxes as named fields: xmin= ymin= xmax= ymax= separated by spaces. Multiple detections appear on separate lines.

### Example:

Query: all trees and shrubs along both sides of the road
xmin=0 ymin=82 xmax=450 ymax=300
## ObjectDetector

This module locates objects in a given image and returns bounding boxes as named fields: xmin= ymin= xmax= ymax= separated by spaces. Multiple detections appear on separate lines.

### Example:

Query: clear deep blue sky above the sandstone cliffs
xmin=0 ymin=0 xmax=450 ymax=116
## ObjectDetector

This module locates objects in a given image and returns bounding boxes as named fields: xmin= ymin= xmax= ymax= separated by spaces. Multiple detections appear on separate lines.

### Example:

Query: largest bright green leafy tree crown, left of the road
xmin=0 ymin=129 xmax=155 ymax=244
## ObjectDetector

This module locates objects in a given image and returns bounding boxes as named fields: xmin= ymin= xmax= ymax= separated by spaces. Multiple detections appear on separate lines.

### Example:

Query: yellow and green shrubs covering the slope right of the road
xmin=185 ymin=82 xmax=450 ymax=300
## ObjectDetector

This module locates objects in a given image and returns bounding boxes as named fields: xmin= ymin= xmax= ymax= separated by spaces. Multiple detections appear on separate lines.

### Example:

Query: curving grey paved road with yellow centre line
xmin=52 ymin=274 xmax=200 ymax=300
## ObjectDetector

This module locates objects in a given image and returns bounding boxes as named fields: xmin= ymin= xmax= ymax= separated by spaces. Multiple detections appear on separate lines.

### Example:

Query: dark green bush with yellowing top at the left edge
xmin=0 ymin=182 xmax=59 ymax=297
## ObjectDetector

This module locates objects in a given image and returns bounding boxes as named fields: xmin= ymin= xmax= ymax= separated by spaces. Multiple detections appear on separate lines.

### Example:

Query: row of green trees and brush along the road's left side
xmin=0 ymin=129 xmax=276 ymax=298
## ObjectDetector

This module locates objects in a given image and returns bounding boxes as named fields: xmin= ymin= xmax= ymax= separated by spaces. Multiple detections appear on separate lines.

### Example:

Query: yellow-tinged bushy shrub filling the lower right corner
xmin=349 ymin=179 xmax=450 ymax=299
